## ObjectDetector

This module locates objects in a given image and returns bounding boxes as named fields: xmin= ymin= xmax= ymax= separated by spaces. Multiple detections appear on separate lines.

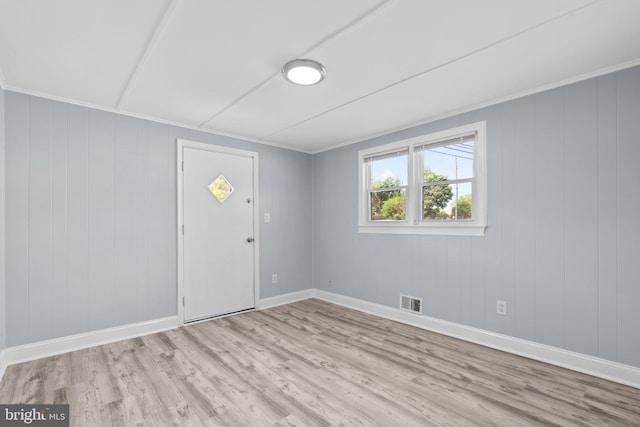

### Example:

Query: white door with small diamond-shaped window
xmin=182 ymin=147 xmax=255 ymax=322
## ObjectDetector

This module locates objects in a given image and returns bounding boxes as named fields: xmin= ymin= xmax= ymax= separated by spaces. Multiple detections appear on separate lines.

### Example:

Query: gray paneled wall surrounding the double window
xmin=313 ymin=67 xmax=640 ymax=367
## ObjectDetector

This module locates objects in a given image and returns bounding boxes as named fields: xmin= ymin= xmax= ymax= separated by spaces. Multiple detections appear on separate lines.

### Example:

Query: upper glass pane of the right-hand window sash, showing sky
xmin=424 ymin=140 xmax=474 ymax=182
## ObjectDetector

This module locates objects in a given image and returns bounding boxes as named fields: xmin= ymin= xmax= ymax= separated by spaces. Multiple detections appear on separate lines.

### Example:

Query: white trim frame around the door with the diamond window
xmin=176 ymin=138 xmax=260 ymax=326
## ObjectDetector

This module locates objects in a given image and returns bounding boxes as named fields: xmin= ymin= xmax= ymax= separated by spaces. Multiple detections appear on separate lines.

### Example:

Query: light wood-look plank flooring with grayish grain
xmin=0 ymin=299 xmax=640 ymax=427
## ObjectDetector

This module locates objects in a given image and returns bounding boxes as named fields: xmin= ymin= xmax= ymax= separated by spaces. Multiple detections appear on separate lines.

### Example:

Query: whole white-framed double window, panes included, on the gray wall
xmin=358 ymin=122 xmax=486 ymax=236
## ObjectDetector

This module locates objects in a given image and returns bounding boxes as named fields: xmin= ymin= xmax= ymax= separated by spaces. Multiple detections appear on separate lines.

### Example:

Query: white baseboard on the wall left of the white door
xmin=0 ymin=316 xmax=178 ymax=380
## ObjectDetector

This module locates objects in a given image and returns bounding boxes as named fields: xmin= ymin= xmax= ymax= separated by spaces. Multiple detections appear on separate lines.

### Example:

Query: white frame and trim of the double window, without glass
xmin=358 ymin=121 xmax=487 ymax=236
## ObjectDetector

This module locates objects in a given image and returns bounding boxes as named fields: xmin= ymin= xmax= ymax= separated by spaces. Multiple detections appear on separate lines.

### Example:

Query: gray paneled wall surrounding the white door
xmin=0 ymin=92 xmax=312 ymax=346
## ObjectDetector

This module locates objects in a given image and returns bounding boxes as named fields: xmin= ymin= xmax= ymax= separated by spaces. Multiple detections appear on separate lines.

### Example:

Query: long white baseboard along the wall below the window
xmin=313 ymin=289 xmax=640 ymax=388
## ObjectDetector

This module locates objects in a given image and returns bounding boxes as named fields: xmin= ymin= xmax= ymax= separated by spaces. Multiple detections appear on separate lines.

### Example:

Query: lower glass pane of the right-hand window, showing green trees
xmin=422 ymin=182 xmax=473 ymax=221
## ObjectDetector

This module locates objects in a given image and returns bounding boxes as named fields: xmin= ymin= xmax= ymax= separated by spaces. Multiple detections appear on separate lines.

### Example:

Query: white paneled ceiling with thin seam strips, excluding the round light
xmin=0 ymin=0 xmax=640 ymax=153
